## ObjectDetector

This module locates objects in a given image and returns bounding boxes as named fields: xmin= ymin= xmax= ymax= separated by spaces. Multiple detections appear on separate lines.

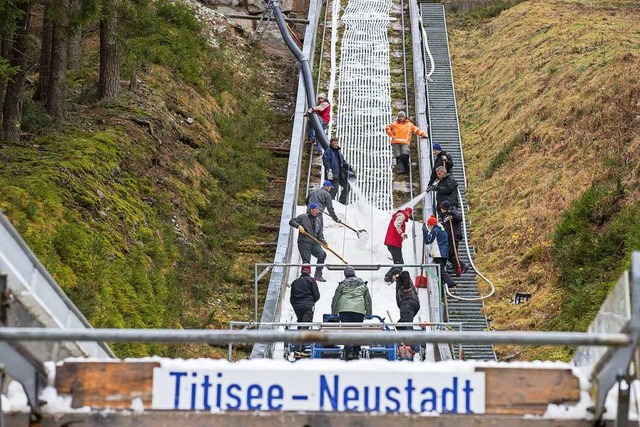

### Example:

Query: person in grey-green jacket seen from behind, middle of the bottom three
xmin=331 ymin=266 xmax=371 ymax=360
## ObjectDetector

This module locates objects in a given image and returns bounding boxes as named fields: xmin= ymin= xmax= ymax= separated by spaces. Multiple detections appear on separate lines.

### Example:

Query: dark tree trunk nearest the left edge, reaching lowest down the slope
xmin=2 ymin=2 xmax=31 ymax=142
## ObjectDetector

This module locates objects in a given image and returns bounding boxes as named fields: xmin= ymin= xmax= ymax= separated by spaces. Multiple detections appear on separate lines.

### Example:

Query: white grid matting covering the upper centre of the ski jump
xmin=335 ymin=0 xmax=393 ymax=211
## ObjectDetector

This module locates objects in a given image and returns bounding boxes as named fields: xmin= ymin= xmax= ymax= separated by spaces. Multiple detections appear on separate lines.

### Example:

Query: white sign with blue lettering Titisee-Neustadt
xmin=152 ymin=368 xmax=485 ymax=414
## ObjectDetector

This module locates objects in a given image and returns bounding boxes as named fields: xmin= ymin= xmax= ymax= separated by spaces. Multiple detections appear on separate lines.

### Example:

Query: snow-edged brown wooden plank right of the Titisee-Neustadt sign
xmin=476 ymin=368 xmax=580 ymax=415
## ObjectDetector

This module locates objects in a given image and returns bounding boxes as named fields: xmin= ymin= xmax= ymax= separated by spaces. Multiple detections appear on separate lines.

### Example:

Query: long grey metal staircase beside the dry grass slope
xmin=420 ymin=3 xmax=496 ymax=360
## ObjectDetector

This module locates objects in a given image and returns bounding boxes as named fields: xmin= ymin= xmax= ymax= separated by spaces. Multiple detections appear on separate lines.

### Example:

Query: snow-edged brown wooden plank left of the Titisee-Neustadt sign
xmin=56 ymin=362 xmax=160 ymax=409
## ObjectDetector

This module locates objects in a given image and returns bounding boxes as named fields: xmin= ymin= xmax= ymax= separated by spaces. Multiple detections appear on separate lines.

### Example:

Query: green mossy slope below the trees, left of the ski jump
xmin=0 ymin=3 xmax=289 ymax=357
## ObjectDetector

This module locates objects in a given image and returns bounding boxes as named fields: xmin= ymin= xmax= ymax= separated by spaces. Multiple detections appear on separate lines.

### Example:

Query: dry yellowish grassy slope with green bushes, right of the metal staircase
xmin=450 ymin=0 xmax=640 ymax=359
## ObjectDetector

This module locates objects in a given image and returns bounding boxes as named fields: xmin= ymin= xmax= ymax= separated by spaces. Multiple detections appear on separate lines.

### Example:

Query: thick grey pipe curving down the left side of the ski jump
xmin=269 ymin=0 xmax=329 ymax=150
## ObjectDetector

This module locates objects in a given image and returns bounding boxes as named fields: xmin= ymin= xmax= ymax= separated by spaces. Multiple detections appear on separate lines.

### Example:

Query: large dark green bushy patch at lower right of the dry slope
xmin=547 ymin=178 xmax=640 ymax=331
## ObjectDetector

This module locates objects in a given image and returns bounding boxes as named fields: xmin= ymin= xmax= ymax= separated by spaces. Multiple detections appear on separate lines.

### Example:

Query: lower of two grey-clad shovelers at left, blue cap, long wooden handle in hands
xmin=289 ymin=203 xmax=329 ymax=282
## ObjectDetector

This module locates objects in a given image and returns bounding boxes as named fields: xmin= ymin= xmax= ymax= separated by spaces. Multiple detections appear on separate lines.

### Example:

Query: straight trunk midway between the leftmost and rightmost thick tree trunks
xmin=47 ymin=0 xmax=69 ymax=120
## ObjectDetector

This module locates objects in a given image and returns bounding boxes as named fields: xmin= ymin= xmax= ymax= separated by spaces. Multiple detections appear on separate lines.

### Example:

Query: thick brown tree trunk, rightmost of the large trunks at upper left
xmin=98 ymin=0 xmax=120 ymax=99
